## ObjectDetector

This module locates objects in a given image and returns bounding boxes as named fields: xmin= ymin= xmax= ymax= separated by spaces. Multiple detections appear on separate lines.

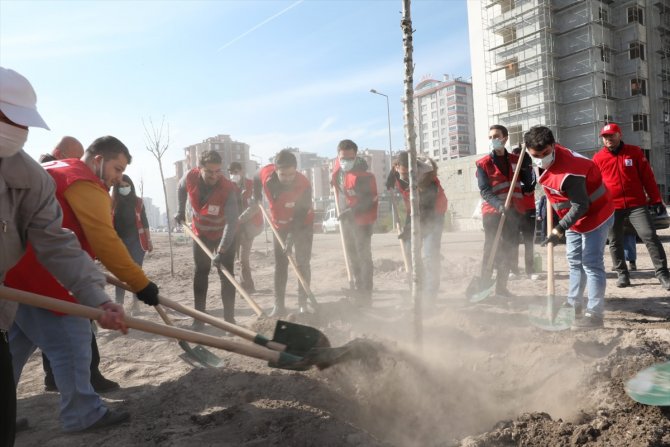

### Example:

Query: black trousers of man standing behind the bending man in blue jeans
xmin=481 ymin=209 xmax=520 ymax=289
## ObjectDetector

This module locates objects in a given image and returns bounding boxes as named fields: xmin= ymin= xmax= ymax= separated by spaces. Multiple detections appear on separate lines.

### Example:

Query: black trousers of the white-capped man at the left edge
xmin=0 ymin=331 xmax=16 ymax=447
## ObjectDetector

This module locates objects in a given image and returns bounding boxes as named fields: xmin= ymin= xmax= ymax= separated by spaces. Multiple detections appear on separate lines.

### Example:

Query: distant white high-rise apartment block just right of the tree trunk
xmin=405 ymin=75 xmax=475 ymax=161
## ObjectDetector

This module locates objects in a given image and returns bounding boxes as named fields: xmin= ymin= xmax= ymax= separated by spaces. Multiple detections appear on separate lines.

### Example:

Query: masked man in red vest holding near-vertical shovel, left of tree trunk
xmin=330 ymin=140 xmax=378 ymax=306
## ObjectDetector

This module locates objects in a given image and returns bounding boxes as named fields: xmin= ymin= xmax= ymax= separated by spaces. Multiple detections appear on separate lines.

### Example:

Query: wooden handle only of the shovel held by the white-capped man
xmin=0 ymin=286 xmax=283 ymax=363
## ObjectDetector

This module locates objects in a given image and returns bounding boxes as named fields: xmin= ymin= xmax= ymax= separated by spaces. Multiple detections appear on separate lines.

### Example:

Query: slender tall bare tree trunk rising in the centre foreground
xmin=400 ymin=0 xmax=423 ymax=344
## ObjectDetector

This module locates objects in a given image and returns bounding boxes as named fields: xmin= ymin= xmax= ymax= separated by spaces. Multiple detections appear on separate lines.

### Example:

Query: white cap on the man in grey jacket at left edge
xmin=0 ymin=67 xmax=49 ymax=129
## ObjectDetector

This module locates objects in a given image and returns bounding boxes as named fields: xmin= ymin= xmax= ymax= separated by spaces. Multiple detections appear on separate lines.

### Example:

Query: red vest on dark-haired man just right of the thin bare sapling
xmin=186 ymin=168 xmax=236 ymax=240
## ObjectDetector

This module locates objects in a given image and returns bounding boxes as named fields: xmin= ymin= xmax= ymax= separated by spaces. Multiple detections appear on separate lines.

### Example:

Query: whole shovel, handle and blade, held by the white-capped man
xmin=0 ymin=286 xmax=312 ymax=371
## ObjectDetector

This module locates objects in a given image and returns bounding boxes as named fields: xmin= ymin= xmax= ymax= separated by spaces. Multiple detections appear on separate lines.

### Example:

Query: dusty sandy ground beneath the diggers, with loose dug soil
xmin=16 ymin=230 xmax=670 ymax=447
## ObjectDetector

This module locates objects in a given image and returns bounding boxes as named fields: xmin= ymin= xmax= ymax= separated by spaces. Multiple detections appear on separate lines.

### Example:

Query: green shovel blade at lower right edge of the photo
xmin=624 ymin=362 xmax=670 ymax=407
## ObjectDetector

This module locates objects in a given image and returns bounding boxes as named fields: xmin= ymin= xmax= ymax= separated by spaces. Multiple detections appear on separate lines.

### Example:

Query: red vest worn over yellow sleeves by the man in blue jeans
xmin=5 ymin=159 xmax=111 ymax=315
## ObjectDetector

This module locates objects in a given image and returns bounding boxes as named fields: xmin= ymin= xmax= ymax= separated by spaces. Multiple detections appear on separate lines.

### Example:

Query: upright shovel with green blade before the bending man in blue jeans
xmin=528 ymin=208 xmax=575 ymax=331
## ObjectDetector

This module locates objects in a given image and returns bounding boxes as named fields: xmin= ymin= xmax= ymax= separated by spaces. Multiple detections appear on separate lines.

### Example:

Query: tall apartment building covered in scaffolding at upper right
xmin=468 ymin=0 xmax=670 ymax=197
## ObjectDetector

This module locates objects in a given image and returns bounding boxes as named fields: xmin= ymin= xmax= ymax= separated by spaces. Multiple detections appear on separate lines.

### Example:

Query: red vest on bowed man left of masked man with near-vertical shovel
xmin=259 ymin=164 xmax=314 ymax=230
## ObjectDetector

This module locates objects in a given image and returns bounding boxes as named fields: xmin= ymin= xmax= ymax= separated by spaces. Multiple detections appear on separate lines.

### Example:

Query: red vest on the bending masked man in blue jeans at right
xmin=538 ymin=144 xmax=614 ymax=233
